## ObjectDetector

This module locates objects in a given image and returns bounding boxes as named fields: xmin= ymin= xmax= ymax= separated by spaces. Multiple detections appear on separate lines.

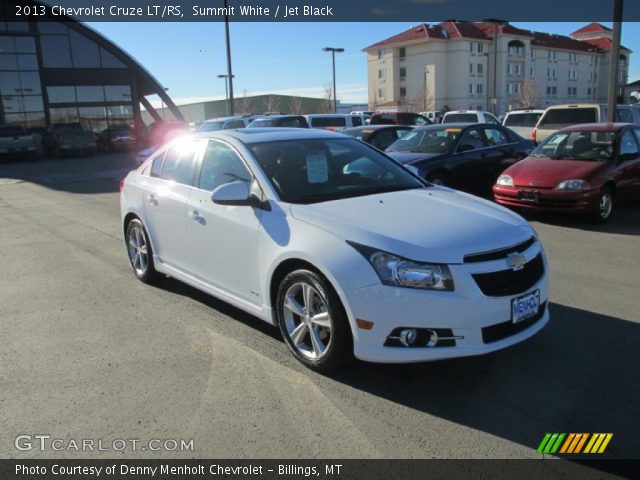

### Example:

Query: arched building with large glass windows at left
xmin=0 ymin=2 xmax=182 ymax=132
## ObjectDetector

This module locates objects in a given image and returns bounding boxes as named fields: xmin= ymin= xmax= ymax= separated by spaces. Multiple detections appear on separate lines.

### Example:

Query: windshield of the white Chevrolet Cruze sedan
xmin=249 ymin=138 xmax=425 ymax=204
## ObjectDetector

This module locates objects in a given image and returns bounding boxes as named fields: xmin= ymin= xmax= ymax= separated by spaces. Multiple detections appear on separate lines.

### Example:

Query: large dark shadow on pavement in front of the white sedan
xmin=333 ymin=304 xmax=640 ymax=458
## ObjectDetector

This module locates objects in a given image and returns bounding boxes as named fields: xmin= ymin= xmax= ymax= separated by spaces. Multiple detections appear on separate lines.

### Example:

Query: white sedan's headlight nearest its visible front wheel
xmin=348 ymin=242 xmax=453 ymax=292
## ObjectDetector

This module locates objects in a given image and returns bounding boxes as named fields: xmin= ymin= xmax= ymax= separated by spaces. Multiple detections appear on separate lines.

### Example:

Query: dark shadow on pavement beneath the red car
xmin=519 ymin=202 xmax=640 ymax=236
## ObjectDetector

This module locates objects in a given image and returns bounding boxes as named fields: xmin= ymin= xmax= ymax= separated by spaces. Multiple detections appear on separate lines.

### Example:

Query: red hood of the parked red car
xmin=505 ymin=157 xmax=606 ymax=188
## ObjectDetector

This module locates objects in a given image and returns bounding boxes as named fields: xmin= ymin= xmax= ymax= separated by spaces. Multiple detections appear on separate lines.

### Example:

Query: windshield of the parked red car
xmin=531 ymin=130 xmax=616 ymax=162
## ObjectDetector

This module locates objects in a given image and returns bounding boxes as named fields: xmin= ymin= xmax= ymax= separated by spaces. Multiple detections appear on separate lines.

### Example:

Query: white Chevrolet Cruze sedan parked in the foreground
xmin=121 ymin=129 xmax=549 ymax=371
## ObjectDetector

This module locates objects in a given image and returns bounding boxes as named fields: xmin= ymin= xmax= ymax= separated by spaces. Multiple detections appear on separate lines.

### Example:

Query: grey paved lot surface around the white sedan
xmin=0 ymin=155 xmax=640 ymax=458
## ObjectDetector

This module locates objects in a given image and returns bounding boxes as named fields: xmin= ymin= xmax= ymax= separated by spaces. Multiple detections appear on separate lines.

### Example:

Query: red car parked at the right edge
xmin=493 ymin=123 xmax=640 ymax=222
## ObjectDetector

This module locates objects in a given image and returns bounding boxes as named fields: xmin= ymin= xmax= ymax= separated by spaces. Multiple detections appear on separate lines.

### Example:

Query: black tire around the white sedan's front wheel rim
xmin=276 ymin=269 xmax=352 ymax=373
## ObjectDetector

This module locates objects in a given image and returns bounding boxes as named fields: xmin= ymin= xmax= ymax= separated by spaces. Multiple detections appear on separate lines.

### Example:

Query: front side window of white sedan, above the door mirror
xmin=198 ymin=141 xmax=252 ymax=192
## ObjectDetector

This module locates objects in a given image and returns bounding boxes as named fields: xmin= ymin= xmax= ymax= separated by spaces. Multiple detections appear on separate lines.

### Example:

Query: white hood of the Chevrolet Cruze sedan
xmin=290 ymin=187 xmax=533 ymax=264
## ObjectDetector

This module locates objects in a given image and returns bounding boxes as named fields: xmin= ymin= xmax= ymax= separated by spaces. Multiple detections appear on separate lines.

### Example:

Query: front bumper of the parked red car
xmin=493 ymin=185 xmax=599 ymax=213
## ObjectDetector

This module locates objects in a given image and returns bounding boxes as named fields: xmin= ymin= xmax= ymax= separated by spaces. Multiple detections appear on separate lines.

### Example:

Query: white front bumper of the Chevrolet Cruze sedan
xmin=347 ymin=242 xmax=549 ymax=363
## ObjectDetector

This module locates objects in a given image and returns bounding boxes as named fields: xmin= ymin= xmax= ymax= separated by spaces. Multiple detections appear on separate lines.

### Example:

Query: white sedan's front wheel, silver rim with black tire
xmin=276 ymin=270 xmax=352 ymax=372
